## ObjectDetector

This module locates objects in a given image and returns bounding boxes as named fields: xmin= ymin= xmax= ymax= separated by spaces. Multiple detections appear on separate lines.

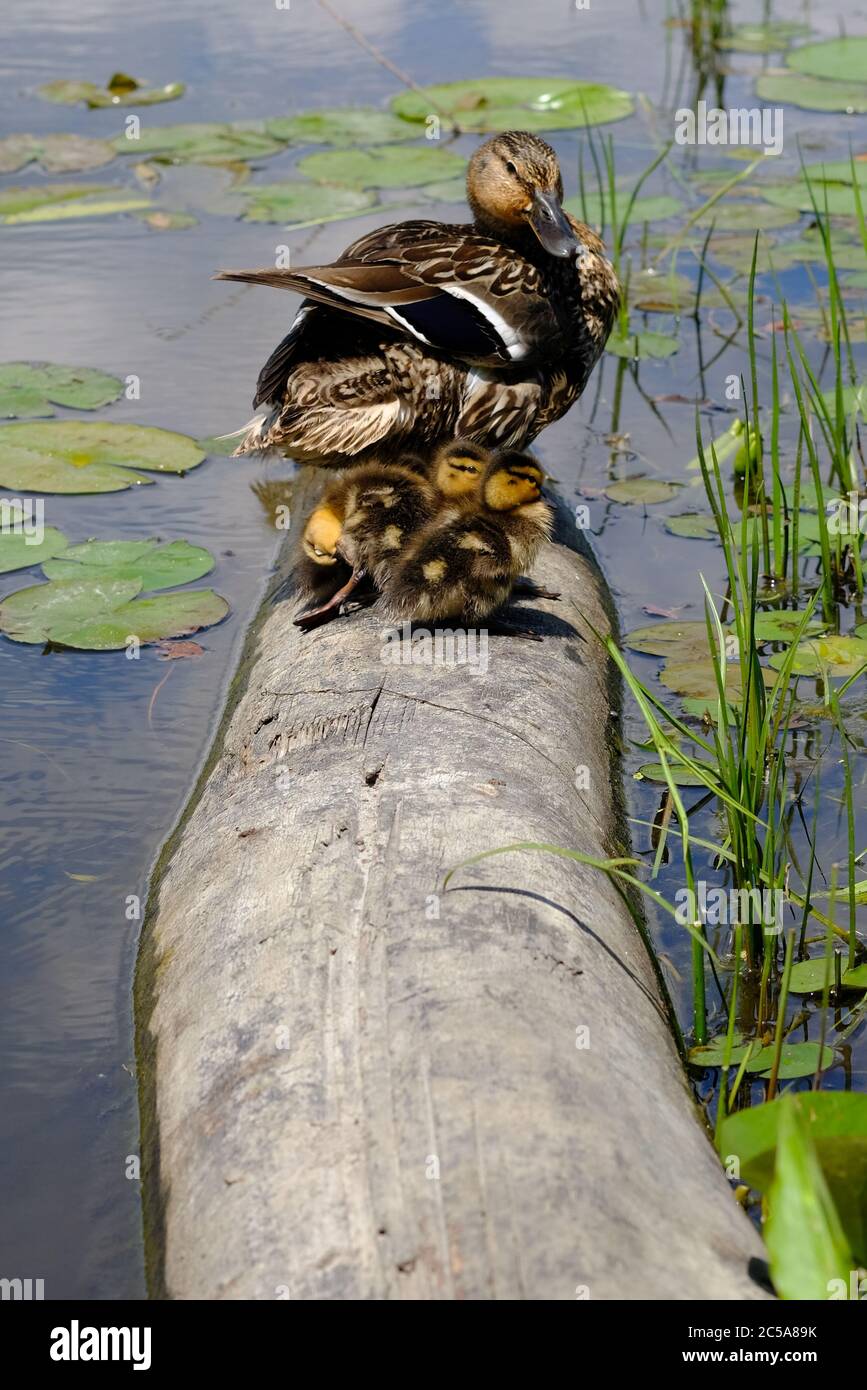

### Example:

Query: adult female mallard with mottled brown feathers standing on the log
xmin=217 ymin=131 xmax=620 ymax=467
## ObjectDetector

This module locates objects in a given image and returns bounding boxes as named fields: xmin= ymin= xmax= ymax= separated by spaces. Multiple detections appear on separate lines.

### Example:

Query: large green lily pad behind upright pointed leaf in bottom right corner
xmin=720 ymin=1091 xmax=867 ymax=1264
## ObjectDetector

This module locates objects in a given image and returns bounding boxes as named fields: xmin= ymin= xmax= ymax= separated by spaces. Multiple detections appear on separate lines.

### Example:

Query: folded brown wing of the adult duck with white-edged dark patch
xmin=217 ymin=221 xmax=561 ymax=367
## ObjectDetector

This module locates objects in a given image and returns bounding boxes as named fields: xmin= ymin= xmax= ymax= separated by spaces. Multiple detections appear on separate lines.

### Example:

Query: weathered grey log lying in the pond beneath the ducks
xmin=138 ymin=478 xmax=763 ymax=1300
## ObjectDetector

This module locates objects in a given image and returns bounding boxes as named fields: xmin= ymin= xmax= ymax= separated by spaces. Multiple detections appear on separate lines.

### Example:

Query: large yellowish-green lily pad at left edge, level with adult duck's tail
xmin=0 ymin=420 xmax=206 ymax=492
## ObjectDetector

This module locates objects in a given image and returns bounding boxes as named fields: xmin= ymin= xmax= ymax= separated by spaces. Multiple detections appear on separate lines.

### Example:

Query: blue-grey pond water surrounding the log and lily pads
xmin=0 ymin=0 xmax=867 ymax=1298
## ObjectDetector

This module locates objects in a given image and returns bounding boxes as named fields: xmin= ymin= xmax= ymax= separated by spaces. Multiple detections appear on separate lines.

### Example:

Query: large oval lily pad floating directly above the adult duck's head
xmin=392 ymin=78 xmax=634 ymax=131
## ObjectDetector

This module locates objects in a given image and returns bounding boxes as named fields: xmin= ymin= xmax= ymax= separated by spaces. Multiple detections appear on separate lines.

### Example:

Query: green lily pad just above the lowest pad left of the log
xmin=42 ymin=539 xmax=214 ymax=589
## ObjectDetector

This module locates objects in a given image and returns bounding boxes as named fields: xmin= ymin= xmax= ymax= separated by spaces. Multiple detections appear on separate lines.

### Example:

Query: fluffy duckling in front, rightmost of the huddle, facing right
xmin=383 ymin=450 xmax=556 ymax=639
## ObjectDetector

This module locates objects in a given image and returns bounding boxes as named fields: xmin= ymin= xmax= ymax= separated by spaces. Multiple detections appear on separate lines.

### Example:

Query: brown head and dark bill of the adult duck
xmin=467 ymin=131 xmax=585 ymax=256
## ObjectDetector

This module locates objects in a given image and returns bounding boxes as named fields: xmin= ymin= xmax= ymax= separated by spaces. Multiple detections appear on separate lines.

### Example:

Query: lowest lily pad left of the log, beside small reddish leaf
xmin=0 ymin=578 xmax=229 ymax=651
